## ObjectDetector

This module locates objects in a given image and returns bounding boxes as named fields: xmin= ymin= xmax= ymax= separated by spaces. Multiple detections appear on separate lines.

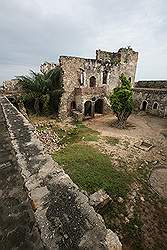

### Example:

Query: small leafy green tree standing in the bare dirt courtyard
xmin=110 ymin=74 xmax=133 ymax=128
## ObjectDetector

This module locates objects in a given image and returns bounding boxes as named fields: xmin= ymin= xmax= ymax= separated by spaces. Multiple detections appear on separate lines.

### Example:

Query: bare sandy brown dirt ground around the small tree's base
xmin=85 ymin=115 xmax=167 ymax=165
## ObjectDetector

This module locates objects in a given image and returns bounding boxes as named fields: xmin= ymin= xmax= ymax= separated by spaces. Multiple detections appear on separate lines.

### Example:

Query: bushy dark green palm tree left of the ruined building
xmin=17 ymin=67 xmax=63 ymax=114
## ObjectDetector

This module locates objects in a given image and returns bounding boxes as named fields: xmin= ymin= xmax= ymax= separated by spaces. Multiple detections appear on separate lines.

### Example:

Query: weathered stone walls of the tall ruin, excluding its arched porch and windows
xmin=60 ymin=48 xmax=138 ymax=117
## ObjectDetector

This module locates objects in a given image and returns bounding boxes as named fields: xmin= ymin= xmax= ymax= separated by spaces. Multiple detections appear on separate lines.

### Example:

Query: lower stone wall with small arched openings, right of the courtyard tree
xmin=133 ymin=88 xmax=167 ymax=117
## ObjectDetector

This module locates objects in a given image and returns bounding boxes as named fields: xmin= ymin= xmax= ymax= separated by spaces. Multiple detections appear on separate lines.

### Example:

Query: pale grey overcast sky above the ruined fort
xmin=0 ymin=0 xmax=167 ymax=82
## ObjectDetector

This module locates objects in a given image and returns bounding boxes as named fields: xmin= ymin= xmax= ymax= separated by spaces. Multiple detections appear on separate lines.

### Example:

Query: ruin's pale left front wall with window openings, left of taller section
xmin=60 ymin=57 xmax=109 ymax=117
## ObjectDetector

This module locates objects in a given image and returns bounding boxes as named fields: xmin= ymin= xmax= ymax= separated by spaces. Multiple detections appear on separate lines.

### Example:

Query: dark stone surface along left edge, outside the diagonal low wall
xmin=0 ymin=104 xmax=46 ymax=250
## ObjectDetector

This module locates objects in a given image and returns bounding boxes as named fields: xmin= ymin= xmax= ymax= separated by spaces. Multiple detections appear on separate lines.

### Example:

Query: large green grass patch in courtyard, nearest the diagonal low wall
xmin=53 ymin=143 xmax=132 ymax=197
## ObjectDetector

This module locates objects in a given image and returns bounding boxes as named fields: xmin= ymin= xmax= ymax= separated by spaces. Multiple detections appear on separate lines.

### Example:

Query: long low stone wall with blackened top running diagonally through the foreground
xmin=0 ymin=97 xmax=122 ymax=250
